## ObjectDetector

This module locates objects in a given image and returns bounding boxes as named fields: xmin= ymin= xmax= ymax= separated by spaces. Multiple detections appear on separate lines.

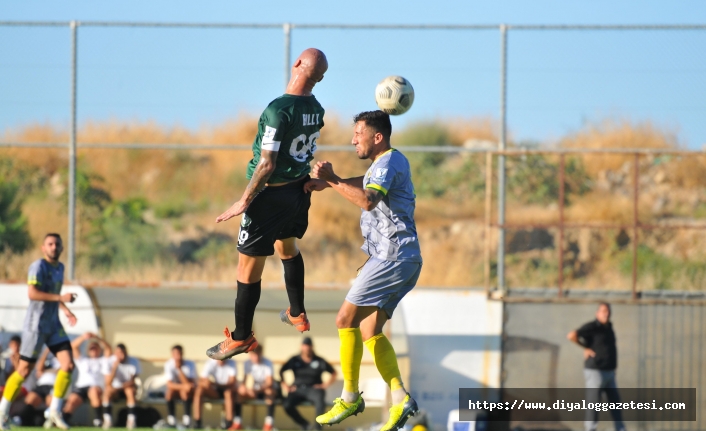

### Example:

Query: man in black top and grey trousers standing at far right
xmin=566 ymin=302 xmax=625 ymax=431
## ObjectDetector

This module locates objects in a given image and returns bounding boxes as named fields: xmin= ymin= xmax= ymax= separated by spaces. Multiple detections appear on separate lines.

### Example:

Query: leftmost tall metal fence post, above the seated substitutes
xmin=67 ymin=21 xmax=78 ymax=280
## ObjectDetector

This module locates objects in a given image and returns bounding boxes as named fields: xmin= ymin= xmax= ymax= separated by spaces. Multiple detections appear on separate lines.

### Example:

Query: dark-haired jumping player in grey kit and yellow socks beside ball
xmin=305 ymin=111 xmax=422 ymax=431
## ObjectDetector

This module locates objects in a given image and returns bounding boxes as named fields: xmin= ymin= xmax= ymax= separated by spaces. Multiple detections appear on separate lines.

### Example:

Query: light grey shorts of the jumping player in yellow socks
xmin=346 ymin=257 xmax=422 ymax=318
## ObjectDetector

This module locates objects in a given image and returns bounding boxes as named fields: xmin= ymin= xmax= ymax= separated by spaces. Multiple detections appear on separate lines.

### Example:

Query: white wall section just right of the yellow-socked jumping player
xmin=392 ymin=289 xmax=503 ymax=429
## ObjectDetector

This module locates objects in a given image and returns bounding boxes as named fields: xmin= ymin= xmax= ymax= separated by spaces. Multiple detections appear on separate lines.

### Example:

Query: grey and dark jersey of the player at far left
xmin=23 ymin=259 xmax=64 ymax=334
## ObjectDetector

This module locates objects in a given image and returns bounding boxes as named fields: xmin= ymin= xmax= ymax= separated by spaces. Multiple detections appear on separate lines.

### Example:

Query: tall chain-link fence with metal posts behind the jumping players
xmin=0 ymin=21 xmax=706 ymax=295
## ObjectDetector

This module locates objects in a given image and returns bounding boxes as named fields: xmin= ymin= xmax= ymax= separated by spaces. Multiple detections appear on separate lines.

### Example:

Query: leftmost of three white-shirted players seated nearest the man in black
xmin=164 ymin=344 xmax=197 ymax=428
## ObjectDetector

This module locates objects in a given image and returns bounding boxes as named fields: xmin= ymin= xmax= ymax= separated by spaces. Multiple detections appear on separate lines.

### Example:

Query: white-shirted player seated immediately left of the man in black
xmin=241 ymin=345 xmax=275 ymax=431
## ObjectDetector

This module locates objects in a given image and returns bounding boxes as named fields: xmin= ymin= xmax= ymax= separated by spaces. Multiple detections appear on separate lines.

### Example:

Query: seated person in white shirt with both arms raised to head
xmin=64 ymin=332 xmax=113 ymax=426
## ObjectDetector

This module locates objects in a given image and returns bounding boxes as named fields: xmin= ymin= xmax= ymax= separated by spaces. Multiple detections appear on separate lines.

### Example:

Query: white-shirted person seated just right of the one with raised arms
xmin=103 ymin=343 xmax=140 ymax=429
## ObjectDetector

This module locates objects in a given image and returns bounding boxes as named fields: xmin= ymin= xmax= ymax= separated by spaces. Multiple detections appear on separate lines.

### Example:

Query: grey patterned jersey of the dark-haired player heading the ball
xmin=360 ymin=148 xmax=422 ymax=262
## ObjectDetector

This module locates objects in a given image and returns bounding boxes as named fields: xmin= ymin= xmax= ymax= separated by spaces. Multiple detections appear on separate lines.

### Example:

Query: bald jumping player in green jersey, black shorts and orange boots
xmin=206 ymin=48 xmax=328 ymax=360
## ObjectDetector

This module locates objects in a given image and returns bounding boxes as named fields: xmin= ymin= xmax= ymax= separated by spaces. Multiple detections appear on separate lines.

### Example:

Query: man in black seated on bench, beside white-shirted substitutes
xmin=279 ymin=337 xmax=336 ymax=430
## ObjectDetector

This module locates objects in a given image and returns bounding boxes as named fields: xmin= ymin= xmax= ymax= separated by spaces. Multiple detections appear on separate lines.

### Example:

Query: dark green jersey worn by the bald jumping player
xmin=247 ymin=94 xmax=324 ymax=184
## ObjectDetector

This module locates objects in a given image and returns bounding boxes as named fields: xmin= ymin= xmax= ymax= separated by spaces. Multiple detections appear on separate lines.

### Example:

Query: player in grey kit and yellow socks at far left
xmin=0 ymin=233 xmax=76 ymax=430
